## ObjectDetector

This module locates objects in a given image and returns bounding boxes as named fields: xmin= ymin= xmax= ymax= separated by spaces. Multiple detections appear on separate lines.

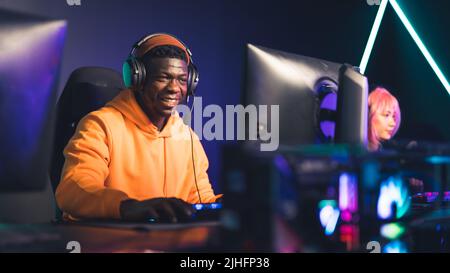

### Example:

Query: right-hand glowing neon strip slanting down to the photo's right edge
xmin=388 ymin=0 xmax=450 ymax=95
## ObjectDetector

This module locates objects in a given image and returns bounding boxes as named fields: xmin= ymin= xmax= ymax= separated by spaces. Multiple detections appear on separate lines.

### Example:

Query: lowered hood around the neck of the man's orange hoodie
xmin=106 ymin=89 xmax=187 ymax=137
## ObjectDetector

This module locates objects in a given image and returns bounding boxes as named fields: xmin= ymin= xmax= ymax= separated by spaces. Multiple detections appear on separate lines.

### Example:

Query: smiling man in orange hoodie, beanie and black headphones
xmin=56 ymin=34 xmax=220 ymax=222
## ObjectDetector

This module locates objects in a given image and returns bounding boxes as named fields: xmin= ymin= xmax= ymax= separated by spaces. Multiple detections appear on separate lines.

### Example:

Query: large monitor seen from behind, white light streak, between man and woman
xmin=243 ymin=44 xmax=341 ymax=147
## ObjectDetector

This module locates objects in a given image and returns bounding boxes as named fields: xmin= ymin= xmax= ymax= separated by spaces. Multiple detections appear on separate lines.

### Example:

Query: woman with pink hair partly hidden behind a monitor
xmin=368 ymin=87 xmax=401 ymax=151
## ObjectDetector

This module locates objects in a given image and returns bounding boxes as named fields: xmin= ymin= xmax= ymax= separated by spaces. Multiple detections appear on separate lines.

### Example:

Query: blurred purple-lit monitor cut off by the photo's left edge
xmin=0 ymin=10 xmax=66 ymax=192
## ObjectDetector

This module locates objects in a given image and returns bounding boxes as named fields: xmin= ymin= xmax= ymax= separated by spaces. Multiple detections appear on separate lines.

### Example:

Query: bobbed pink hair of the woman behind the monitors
xmin=369 ymin=87 xmax=401 ymax=151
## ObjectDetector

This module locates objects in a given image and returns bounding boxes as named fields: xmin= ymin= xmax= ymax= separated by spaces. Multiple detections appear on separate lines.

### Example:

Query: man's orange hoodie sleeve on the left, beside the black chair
xmin=56 ymin=114 xmax=129 ymax=219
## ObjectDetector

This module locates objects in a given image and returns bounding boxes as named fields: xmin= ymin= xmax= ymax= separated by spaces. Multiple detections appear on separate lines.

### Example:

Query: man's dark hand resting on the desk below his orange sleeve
xmin=120 ymin=198 xmax=195 ymax=223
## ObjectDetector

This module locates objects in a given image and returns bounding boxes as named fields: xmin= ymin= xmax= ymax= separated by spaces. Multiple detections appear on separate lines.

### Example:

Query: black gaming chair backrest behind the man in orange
xmin=50 ymin=67 xmax=125 ymax=191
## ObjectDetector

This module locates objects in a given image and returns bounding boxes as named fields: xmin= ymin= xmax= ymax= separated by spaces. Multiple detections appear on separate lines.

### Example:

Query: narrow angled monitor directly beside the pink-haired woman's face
xmin=335 ymin=64 xmax=369 ymax=147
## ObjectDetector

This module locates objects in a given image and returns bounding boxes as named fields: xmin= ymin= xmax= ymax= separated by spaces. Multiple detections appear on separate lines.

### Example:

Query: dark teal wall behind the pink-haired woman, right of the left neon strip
xmin=366 ymin=1 xmax=450 ymax=141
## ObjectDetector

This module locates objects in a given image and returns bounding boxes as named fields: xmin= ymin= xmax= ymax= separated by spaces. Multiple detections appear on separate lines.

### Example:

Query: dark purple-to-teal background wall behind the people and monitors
xmin=0 ymin=0 xmax=450 ymax=196
